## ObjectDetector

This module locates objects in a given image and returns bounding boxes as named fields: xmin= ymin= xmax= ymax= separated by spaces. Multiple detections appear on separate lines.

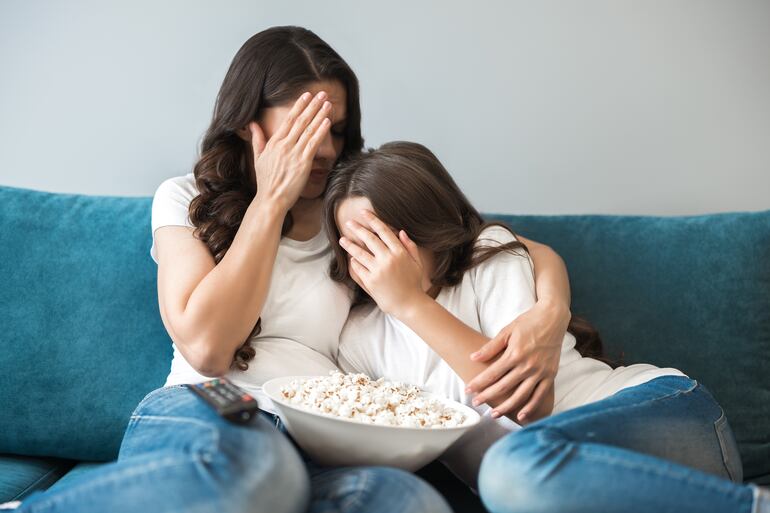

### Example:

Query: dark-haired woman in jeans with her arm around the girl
xmin=4 ymin=27 xmax=569 ymax=513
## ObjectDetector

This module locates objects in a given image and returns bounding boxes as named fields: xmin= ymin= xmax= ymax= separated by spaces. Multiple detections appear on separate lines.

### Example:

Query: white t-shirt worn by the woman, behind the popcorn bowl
xmin=150 ymin=173 xmax=352 ymax=413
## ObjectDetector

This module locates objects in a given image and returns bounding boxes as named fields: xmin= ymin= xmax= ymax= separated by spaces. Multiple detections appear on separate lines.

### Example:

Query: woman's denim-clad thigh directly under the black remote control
xmin=118 ymin=385 xmax=310 ymax=511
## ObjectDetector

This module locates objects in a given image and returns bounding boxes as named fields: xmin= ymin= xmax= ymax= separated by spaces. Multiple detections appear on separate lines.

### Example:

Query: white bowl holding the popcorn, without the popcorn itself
xmin=262 ymin=376 xmax=480 ymax=471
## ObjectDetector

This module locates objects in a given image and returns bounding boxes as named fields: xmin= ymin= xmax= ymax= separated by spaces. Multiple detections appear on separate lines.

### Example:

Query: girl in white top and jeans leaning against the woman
xmin=324 ymin=142 xmax=770 ymax=513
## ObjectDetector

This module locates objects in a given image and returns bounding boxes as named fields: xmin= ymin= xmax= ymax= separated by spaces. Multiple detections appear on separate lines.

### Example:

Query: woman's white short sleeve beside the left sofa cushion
xmin=150 ymin=173 xmax=198 ymax=264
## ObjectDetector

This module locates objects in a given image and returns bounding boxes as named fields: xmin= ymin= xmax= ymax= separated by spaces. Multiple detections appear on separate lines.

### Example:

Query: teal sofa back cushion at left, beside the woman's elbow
xmin=0 ymin=187 xmax=171 ymax=460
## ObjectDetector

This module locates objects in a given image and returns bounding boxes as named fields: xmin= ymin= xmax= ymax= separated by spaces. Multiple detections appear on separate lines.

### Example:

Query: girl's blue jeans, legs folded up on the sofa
xmin=479 ymin=376 xmax=770 ymax=513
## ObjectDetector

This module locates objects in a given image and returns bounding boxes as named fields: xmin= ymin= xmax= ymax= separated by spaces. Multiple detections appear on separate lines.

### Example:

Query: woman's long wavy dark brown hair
xmin=189 ymin=27 xmax=363 ymax=370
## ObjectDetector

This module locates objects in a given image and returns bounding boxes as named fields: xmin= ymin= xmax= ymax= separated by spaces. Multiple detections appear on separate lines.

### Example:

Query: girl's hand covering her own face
xmin=340 ymin=210 xmax=426 ymax=317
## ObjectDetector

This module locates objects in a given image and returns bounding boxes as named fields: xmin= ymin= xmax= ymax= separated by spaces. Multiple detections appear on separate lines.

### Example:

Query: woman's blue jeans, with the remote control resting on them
xmin=17 ymin=385 xmax=451 ymax=513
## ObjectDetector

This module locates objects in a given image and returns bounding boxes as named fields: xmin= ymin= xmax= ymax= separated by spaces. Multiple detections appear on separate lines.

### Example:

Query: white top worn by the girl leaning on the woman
xmin=337 ymin=227 xmax=684 ymax=488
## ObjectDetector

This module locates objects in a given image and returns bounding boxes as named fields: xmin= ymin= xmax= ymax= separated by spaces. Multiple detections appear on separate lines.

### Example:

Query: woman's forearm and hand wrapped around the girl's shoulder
xmin=466 ymin=235 xmax=571 ymax=420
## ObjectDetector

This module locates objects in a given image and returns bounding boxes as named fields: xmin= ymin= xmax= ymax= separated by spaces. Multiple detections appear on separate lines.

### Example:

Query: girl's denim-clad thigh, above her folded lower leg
xmin=522 ymin=376 xmax=742 ymax=482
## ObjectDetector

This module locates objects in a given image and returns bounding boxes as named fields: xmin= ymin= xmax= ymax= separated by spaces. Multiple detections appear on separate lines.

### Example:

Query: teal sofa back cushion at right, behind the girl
xmin=489 ymin=211 xmax=770 ymax=484
